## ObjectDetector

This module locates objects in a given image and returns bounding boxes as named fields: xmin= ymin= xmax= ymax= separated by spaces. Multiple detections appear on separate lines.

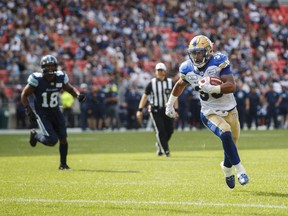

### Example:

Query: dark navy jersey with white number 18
xmin=28 ymin=71 xmax=69 ymax=113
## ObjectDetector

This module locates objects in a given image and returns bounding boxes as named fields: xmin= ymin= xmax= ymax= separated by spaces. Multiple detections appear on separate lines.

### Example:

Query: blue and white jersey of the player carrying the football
xmin=179 ymin=53 xmax=236 ymax=116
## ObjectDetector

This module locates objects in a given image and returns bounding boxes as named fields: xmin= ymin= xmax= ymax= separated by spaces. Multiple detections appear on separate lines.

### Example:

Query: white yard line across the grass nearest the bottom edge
xmin=0 ymin=198 xmax=288 ymax=209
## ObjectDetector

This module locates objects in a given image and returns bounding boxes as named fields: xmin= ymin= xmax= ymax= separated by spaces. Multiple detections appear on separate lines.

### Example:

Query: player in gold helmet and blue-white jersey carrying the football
xmin=165 ymin=35 xmax=249 ymax=189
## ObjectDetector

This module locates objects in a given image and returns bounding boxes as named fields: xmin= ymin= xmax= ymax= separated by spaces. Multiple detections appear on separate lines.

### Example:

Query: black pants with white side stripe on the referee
xmin=150 ymin=109 xmax=174 ymax=154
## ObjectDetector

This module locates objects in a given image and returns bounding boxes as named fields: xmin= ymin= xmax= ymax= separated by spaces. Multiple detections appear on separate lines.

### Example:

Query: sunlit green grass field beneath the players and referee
xmin=0 ymin=130 xmax=288 ymax=216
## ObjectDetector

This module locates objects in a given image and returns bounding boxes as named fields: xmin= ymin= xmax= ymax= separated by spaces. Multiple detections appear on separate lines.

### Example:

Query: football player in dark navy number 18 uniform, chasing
xmin=21 ymin=55 xmax=85 ymax=170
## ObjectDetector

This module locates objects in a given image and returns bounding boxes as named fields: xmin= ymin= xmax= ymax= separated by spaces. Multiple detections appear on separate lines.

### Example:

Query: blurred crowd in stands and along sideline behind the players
xmin=0 ymin=0 xmax=288 ymax=130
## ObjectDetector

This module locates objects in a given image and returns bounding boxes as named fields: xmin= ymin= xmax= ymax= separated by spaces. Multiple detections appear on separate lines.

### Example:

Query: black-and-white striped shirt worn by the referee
xmin=145 ymin=78 xmax=173 ymax=108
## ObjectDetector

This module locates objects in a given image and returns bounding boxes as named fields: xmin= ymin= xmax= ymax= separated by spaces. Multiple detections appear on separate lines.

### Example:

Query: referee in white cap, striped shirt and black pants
xmin=136 ymin=62 xmax=178 ymax=157
